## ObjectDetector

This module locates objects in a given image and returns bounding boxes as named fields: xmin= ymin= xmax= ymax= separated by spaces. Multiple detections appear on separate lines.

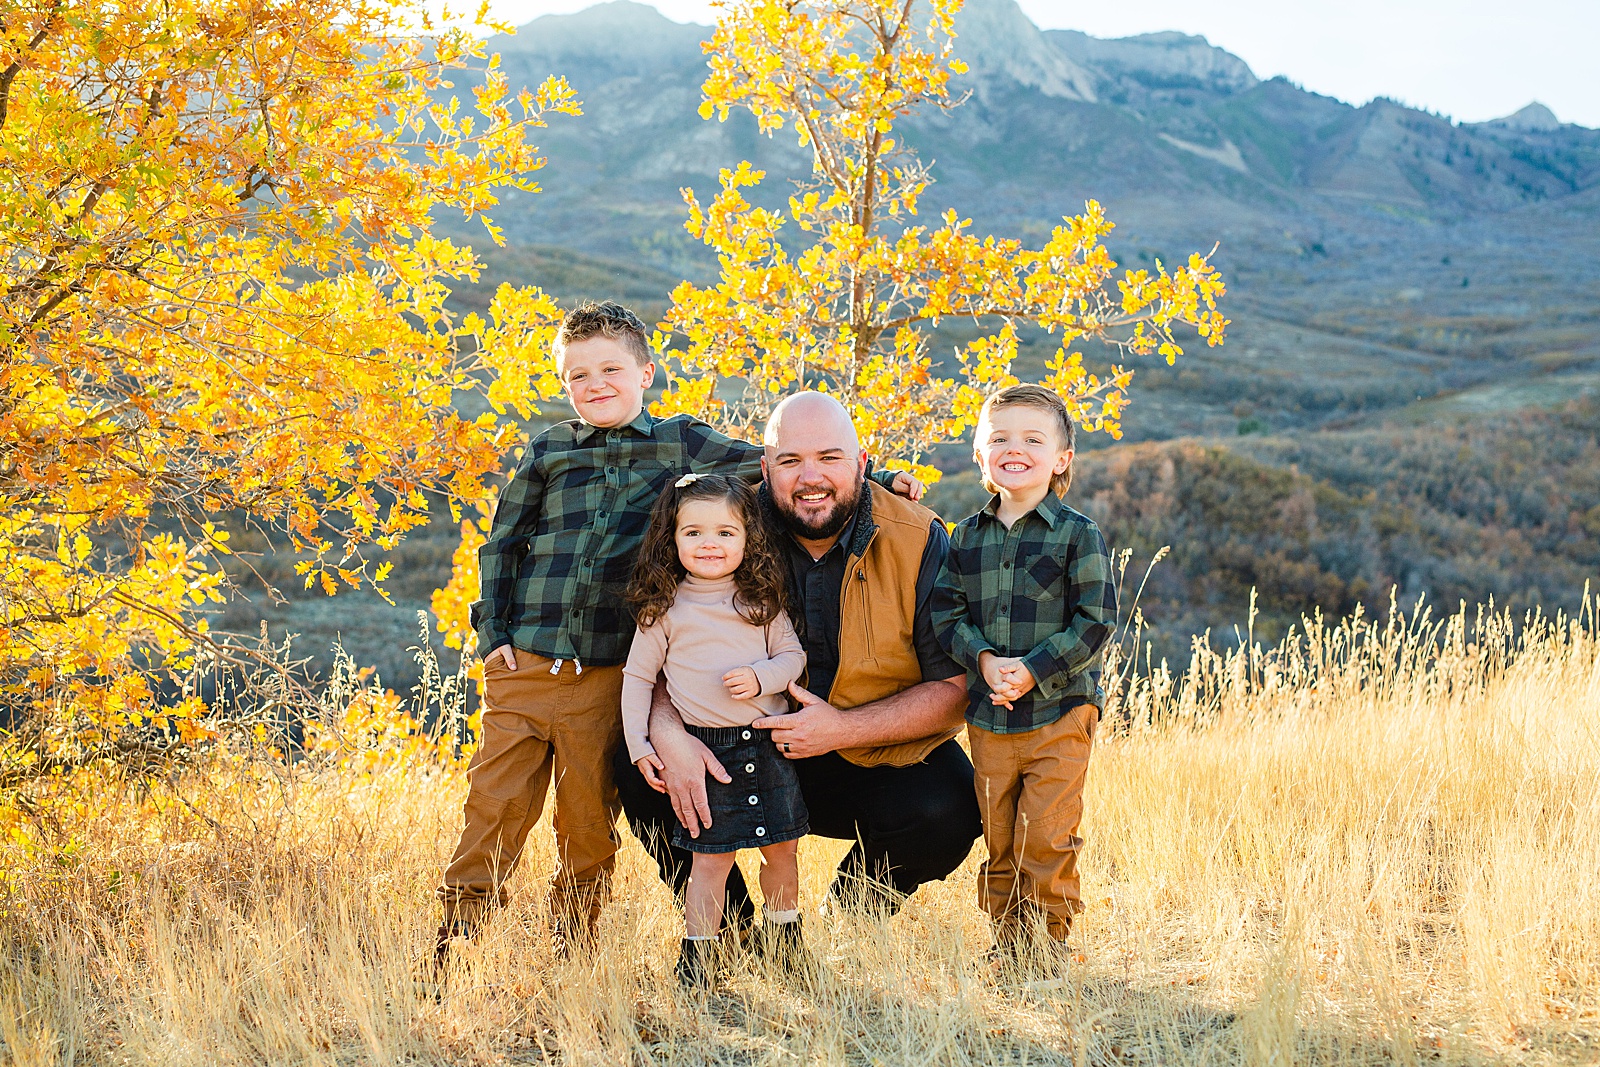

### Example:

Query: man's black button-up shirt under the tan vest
xmin=768 ymin=488 xmax=963 ymax=699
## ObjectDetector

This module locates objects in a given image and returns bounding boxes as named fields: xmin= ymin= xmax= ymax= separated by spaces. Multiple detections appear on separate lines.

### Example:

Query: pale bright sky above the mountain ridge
xmin=473 ymin=0 xmax=1600 ymax=126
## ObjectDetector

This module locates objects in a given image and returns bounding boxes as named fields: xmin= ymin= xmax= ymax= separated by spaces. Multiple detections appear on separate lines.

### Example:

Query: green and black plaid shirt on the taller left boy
xmin=472 ymin=411 xmax=894 ymax=667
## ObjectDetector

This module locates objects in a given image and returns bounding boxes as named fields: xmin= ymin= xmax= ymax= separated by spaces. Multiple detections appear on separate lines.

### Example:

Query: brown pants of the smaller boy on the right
xmin=966 ymin=704 xmax=1099 ymax=941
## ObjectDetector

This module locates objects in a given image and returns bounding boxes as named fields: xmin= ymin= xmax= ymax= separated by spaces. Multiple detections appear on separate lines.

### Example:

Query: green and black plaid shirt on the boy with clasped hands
xmin=933 ymin=493 xmax=1117 ymax=734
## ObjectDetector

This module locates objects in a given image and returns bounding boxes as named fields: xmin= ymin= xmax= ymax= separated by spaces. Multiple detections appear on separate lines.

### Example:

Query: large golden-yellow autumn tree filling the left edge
xmin=0 ymin=0 xmax=578 ymax=763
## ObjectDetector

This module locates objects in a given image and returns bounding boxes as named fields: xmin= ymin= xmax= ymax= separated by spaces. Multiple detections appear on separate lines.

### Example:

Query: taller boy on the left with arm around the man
xmin=435 ymin=301 xmax=922 ymax=965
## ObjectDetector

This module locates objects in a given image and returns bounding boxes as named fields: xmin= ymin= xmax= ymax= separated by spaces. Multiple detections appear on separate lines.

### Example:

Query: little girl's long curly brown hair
xmin=627 ymin=474 xmax=789 ymax=629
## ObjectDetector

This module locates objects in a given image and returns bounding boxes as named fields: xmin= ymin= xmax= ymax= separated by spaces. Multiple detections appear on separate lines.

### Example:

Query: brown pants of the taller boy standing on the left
xmin=438 ymin=649 xmax=622 ymax=934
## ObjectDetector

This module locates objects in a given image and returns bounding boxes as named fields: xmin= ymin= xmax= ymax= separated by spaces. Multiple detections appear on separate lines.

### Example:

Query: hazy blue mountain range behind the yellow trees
xmin=438 ymin=0 xmax=1600 ymax=454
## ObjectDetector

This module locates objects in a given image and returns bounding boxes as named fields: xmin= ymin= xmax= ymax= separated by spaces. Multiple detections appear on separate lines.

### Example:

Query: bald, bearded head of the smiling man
xmin=762 ymin=392 xmax=864 ymax=542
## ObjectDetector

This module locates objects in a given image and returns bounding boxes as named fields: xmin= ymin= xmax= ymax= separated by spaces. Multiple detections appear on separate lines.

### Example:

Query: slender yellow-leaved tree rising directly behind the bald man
xmin=658 ymin=0 xmax=1227 ymax=480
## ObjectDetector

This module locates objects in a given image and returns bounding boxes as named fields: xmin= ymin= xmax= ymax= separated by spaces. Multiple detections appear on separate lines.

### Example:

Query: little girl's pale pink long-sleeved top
xmin=622 ymin=574 xmax=805 ymax=763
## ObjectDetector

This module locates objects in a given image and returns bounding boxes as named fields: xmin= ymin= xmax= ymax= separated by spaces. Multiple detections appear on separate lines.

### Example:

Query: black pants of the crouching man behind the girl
xmin=616 ymin=741 xmax=982 ymax=925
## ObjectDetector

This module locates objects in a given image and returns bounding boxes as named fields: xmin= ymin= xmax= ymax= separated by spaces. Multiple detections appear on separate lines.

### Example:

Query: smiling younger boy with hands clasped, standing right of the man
xmin=933 ymin=386 xmax=1117 ymax=958
